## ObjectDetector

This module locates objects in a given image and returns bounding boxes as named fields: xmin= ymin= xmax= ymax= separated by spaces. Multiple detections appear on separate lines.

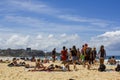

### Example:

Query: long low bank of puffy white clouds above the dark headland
xmin=0 ymin=33 xmax=83 ymax=51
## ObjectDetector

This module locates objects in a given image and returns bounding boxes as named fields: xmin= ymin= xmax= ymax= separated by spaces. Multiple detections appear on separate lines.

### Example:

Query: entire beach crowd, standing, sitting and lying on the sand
xmin=0 ymin=44 xmax=120 ymax=71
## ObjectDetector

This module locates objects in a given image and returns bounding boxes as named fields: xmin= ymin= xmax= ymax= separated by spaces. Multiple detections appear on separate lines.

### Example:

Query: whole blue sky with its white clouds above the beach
xmin=0 ymin=0 xmax=120 ymax=55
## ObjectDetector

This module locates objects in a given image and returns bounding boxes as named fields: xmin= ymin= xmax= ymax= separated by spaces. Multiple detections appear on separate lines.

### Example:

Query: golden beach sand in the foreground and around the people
xmin=0 ymin=61 xmax=120 ymax=80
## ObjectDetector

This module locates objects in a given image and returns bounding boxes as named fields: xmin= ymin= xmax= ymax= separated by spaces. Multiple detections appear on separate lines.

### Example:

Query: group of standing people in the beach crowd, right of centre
xmin=52 ymin=44 xmax=106 ymax=70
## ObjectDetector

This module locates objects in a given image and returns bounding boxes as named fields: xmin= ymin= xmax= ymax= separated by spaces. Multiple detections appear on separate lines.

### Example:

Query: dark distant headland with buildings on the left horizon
xmin=0 ymin=48 xmax=45 ymax=57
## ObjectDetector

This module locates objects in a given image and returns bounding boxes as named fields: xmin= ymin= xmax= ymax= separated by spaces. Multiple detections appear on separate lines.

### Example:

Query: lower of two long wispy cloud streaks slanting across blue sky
xmin=4 ymin=16 xmax=109 ymax=33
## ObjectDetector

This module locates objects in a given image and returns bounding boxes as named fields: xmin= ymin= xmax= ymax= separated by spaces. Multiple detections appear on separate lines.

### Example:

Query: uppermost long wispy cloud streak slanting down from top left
xmin=1 ymin=0 xmax=111 ymax=27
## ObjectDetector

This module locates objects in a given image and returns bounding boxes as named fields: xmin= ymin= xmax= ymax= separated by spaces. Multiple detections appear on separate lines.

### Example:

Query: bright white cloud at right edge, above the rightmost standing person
xmin=91 ymin=30 xmax=120 ymax=51
